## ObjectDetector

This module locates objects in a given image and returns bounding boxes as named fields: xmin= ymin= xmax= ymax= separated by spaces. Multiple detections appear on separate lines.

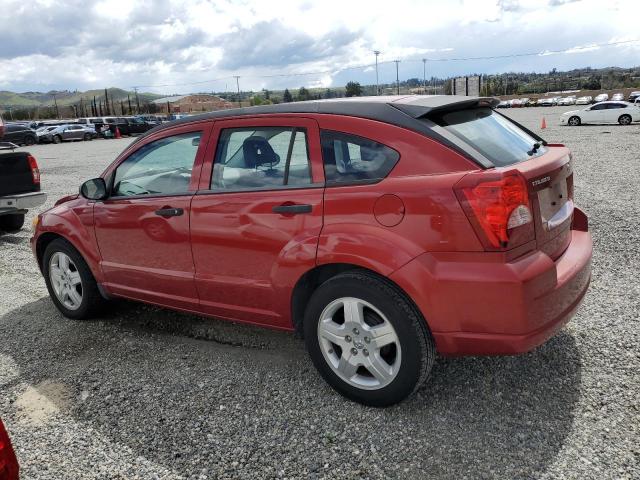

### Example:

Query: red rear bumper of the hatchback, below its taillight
xmin=391 ymin=209 xmax=592 ymax=355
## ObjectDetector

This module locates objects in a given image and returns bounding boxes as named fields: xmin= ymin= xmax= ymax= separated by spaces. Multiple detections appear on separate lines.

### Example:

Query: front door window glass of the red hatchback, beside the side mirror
xmin=111 ymin=132 xmax=202 ymax=197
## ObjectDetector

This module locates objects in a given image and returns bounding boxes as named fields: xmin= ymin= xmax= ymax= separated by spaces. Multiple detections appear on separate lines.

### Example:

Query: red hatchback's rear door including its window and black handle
xmin=191 ymin=117 xmax=324 ymax=328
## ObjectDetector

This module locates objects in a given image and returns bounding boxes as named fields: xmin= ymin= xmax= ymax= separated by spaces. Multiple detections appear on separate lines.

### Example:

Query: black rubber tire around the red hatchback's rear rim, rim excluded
xmin=304 ymin=270 xmax=436 ymax=407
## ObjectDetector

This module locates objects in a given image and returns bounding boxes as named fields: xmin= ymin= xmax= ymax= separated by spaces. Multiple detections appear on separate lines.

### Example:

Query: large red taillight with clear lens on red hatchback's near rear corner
xmin=456 ymin=172 xmax=535 ymax=250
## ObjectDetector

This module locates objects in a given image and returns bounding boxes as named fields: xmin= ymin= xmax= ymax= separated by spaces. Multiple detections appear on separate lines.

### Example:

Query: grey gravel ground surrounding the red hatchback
xmin=0 ymin=107 xmax=640 ymax=479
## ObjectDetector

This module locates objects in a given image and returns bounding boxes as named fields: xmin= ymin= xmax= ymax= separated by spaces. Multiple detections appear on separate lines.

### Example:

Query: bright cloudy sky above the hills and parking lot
xmin=0 ymin=0 xmax=640 ymax=93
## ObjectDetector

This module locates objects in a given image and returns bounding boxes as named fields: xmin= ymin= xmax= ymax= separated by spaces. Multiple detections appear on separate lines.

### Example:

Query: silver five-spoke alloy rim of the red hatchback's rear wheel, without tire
xmin=318 ymin=297 xmax=402 ymax=390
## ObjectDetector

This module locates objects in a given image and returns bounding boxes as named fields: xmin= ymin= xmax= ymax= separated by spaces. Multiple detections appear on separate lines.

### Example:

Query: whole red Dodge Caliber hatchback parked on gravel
xmin=31 ymin=96 xmax=592 ymax=406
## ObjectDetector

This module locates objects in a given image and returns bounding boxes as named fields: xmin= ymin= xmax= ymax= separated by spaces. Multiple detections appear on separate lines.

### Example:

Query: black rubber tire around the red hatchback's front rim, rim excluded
xmin=42 ymin=238 xmax=105 ymax=320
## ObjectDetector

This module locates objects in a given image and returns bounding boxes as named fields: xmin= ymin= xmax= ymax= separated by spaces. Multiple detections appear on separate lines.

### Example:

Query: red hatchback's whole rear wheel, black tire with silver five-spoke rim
xmin=304 ymin=271 xmax=435 ymax=407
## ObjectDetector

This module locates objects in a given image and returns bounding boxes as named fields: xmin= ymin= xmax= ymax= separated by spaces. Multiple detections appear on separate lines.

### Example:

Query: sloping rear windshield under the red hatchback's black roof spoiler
xmin=431 ymin=108 xmax=547 ymax=167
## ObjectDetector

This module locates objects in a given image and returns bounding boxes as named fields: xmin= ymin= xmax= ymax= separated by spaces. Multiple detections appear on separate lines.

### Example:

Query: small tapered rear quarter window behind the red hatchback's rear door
xmin=320 ymin=130 xmax=400 ymax=185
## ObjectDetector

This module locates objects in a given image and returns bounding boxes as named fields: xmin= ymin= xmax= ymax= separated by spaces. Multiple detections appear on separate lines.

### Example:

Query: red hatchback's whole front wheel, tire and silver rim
xmin=42 ymin=238 xmax=104 ymax=320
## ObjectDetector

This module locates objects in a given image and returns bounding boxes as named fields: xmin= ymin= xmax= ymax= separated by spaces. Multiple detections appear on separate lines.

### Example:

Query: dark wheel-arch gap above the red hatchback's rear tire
xmin=291 ymin=263 xmax=431 ymax=337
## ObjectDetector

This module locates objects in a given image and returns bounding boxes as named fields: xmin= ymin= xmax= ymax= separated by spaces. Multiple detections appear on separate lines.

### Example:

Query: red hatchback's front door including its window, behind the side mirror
xmin=94 ymin=126 xmax=209 ymax=310
